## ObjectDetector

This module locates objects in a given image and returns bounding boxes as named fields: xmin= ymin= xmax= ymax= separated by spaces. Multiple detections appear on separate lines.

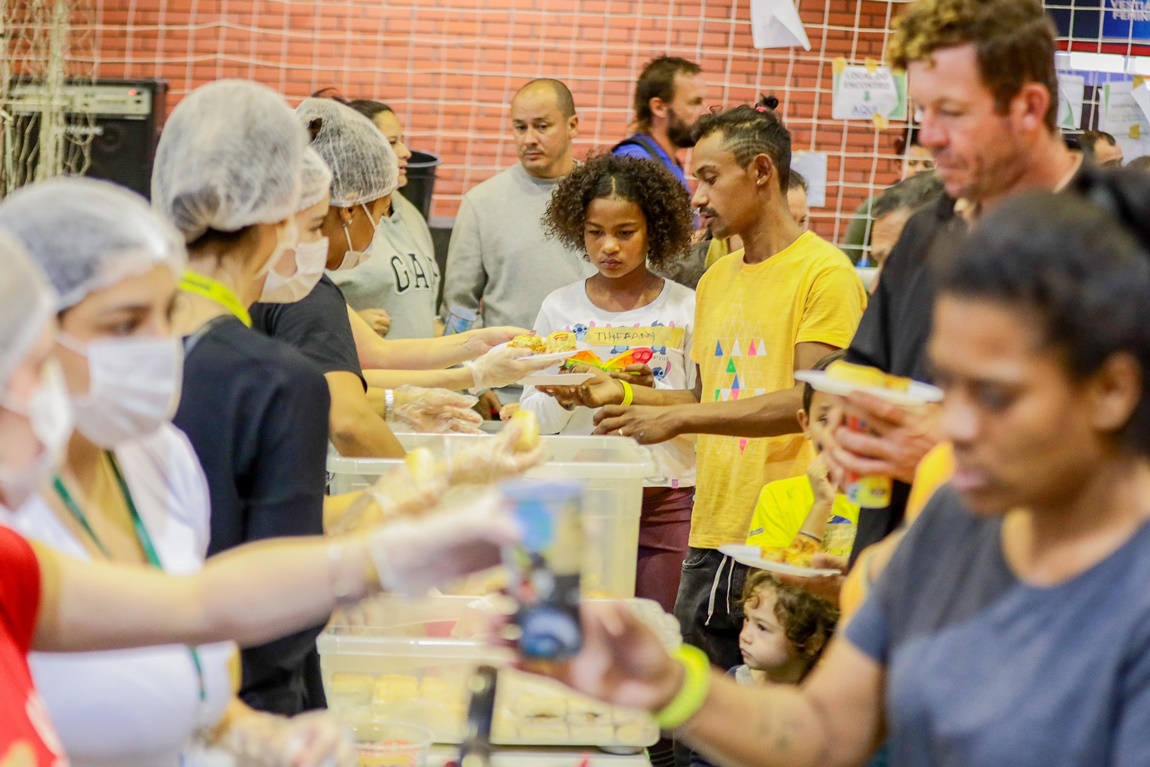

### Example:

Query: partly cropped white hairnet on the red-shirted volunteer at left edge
xmin=0 ymin=231 xmax=56 ymax=394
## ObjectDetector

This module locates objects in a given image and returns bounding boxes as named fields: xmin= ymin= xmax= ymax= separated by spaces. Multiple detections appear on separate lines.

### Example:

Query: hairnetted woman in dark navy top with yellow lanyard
xmin=152 ymin=80 xmax=338 ymax=715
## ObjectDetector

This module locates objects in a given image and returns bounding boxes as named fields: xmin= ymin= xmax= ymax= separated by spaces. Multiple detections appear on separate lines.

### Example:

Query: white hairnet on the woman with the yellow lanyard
xmin=152 ymin=79 xmax=307 ymax=243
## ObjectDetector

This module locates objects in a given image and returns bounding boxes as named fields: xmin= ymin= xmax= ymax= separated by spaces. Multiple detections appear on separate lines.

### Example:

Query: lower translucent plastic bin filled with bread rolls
xmin=316 ymin=597 xmax=680 ymax=749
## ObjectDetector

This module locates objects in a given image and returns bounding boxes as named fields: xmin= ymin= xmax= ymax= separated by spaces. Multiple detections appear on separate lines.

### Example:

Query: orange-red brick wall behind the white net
xmin=85 ymin=0 xmax=902 ymax=237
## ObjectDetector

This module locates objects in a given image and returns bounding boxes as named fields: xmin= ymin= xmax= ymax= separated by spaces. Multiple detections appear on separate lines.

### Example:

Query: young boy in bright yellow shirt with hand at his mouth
xmin=746 ymin=351 xmax=859 ymax=557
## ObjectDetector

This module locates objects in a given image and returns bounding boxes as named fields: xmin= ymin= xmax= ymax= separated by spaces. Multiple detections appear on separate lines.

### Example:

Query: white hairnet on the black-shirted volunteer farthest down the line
xmin=296 ymin=98 xmax=399 ymax=208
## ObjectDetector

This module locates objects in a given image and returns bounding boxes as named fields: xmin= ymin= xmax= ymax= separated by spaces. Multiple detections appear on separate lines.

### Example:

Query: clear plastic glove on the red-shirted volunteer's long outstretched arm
xmin=368 ymin=489 xmax=522 ymax=597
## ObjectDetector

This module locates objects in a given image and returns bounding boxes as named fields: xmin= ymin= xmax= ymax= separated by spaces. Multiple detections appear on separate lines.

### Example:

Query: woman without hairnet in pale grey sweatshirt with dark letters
xmin=332 ymin=99 xmax=442 ymax=339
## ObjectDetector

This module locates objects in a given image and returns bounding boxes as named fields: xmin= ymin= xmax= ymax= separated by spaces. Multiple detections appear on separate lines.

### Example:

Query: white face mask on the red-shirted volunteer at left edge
xmin=0 ymin=360 xmax=72 ymax=511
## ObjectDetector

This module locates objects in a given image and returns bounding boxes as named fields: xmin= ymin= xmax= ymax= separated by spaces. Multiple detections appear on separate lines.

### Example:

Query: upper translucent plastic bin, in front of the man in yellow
xmin=328 ymin=434 xmax=654 ymax=599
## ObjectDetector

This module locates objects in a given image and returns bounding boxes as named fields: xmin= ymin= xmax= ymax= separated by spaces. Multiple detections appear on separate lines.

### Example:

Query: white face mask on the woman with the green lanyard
xmin=58 ymin=335 xmax=184 ymax=448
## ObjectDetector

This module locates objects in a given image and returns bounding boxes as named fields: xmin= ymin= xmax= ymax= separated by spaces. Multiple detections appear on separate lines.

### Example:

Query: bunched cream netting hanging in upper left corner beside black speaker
xmin=0 ymin=0 xmax=95 ymax=193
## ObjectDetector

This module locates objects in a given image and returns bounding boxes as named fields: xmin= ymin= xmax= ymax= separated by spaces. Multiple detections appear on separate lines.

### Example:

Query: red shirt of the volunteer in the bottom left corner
xmin=0 ymin=528 xmax=68 ymax=767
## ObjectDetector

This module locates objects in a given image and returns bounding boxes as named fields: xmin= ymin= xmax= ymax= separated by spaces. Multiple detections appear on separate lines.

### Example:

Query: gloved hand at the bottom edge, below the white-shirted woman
xmin=221 ymin=711 xmax=357 ymax=767
